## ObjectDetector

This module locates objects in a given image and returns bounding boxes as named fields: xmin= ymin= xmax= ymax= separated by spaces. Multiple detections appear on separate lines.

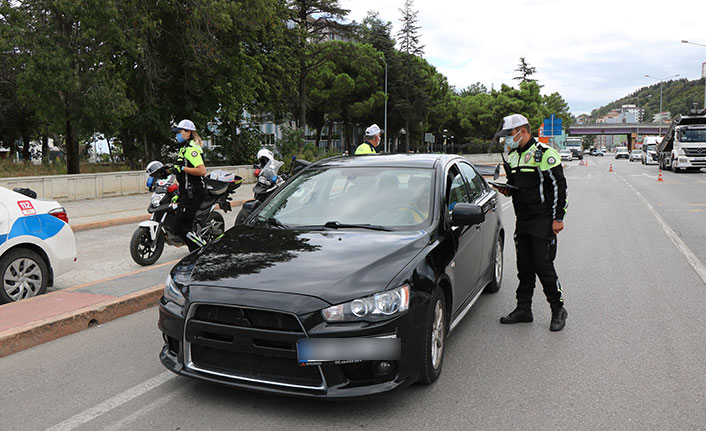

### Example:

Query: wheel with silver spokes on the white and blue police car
xmin=0 ymin=248 xmax=49 ymax=304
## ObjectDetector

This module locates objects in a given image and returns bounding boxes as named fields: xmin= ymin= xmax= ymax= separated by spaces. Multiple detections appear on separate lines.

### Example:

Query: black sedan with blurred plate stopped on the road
xmin=159 ymin=155 xmax=505 ymax=398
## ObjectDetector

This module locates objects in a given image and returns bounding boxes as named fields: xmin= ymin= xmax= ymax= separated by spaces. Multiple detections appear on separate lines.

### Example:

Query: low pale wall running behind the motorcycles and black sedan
xmin=0 ymin=154 xmax=502 ymax=201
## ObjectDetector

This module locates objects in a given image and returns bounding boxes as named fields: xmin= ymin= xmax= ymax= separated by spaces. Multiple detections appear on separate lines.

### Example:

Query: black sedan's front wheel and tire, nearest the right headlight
xmin=419 ymin=286 xmax=448 ymax=385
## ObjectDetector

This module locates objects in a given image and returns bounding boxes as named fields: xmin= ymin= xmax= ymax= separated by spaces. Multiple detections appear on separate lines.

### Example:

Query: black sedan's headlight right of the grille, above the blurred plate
xmin=321 ymin=285 xmax=409 ymax=323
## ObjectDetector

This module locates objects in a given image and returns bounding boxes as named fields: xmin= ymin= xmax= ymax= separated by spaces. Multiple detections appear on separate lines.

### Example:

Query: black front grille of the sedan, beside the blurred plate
xmin=184 ymin=304 xmax=324 ymax=389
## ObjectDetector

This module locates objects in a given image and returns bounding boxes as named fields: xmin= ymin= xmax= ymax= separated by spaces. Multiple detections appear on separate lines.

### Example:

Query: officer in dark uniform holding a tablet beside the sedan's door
xmin=496 ymin=114 xmax=568 ymax=331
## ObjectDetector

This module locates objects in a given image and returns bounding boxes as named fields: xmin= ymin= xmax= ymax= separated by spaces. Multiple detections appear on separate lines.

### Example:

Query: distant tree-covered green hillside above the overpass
xmin=591 ymin=78 xmax=704 ymax=122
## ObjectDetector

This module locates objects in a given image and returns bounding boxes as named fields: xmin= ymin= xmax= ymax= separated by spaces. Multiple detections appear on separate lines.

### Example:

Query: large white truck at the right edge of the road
xmin=656 ymin=109 xmax=706 ymax=172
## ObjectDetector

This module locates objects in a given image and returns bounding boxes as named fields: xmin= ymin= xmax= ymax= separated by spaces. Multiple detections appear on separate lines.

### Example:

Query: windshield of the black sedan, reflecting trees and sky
xmin=255 ymin=167 xmax=434 ymax=229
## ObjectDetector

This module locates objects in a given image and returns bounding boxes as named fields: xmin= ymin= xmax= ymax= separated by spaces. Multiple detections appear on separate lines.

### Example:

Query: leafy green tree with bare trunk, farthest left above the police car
xmin=16 ymin=0 xmax=134 ymax=174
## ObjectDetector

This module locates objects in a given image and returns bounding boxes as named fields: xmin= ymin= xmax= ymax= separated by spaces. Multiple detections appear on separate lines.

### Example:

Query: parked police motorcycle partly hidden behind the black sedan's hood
xmin=235 ymin=148 xmax=311 ymax=225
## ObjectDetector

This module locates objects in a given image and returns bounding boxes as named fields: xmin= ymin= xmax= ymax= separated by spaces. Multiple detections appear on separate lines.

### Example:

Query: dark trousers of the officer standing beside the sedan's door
xmin=515 ymin=233 xmax=564 ymax=311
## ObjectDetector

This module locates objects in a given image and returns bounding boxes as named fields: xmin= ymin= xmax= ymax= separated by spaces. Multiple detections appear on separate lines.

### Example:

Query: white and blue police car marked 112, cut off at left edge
xmin=0 ymin=187 xmax=76 ymax=304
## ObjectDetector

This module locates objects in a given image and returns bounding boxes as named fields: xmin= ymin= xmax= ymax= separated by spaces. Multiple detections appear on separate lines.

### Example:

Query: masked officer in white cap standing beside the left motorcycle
xmin=172 ymin=120 xmax=207 ymax=251
